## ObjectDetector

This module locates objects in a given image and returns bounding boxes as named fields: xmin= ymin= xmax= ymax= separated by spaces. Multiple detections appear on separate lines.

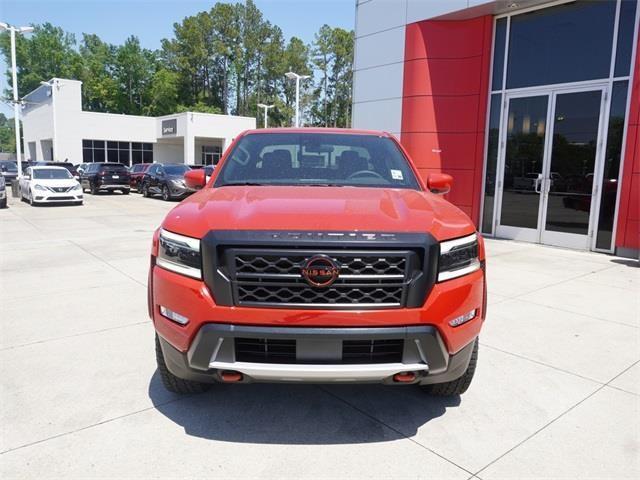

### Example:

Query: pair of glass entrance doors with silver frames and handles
xmin=496 ymin=87 xmax=604 ymax=249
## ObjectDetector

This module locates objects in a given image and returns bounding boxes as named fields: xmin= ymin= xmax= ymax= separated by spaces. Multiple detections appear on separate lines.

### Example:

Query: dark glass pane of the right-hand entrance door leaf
xmin=545 ymin=90 xmax=602 ymax=235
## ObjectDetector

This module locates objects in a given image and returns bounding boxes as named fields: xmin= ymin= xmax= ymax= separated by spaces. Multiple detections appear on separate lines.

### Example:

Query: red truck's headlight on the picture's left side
xmin=156 ymin=229 xmax=202 ymax=279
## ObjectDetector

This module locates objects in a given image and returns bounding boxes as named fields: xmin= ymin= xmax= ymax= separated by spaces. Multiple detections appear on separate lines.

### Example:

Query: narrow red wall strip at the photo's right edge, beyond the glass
xmin=616 ymin=33 xmax=640 ymax=250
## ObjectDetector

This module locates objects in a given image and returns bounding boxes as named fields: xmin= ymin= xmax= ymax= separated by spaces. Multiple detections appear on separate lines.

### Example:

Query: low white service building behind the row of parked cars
xmin=22 ymin=78 xmax=256 ymax=165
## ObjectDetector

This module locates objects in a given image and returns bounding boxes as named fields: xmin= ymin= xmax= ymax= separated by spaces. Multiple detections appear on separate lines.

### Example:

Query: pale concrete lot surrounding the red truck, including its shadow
xmin=0 ymin=194 xmax=640 ymax=479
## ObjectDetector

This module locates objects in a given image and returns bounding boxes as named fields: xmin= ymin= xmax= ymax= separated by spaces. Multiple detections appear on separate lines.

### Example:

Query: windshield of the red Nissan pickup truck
xmin=215 ymin=133 xmax=420 ymax=190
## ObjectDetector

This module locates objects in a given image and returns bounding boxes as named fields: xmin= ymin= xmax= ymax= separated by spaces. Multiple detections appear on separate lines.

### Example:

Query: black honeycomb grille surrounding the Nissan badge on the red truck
xmin=225 ymin=249 xmax=421 ymax=308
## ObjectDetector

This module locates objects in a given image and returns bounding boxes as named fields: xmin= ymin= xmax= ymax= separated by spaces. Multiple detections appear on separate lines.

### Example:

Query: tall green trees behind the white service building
xmin=0 ymin=0 xmax=354 ymax=150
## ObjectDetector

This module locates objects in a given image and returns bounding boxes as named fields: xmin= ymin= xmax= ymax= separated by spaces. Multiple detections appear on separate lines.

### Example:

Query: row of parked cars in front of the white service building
xmin=0 ymin=161 xmax=215 ymax=207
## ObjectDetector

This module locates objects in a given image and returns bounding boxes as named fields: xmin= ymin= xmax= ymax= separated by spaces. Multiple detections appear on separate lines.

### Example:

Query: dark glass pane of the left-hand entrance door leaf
xmin=500 ymin=95 xmax=549 ymax=228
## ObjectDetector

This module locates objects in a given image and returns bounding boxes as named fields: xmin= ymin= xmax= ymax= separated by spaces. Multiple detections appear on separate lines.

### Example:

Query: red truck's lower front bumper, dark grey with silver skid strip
xmin=160 ymin=324 xmax=474 ymax=385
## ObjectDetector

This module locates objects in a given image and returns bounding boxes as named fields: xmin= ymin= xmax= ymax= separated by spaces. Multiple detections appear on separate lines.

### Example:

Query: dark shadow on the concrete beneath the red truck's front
xmin=149 ymin=371 xmax=460 ymax=445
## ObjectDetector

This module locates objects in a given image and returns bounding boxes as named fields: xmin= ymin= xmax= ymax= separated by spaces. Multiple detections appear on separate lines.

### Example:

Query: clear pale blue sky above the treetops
xmin=0 ymin=0 xmax=355 ymax=116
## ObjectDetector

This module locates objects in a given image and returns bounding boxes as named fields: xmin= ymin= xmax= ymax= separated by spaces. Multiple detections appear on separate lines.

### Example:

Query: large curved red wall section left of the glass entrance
xmin=401 ymin=15 xmax=493 ymax=225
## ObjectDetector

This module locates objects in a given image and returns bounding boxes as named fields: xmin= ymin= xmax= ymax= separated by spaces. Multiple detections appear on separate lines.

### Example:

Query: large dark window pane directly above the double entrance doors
xmin=507 ymin=1 xmax=616 ymax=88
